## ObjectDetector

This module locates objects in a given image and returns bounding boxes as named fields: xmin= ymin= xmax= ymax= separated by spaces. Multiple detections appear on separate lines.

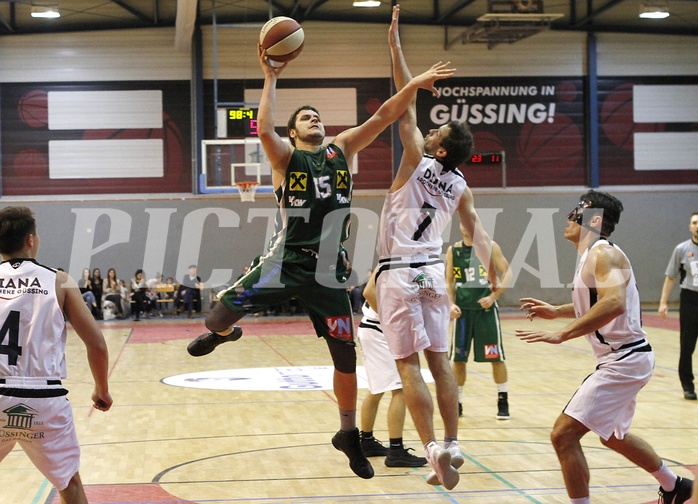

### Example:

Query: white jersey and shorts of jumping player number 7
xmin=376 ymin=156 xmax=467 ymax=359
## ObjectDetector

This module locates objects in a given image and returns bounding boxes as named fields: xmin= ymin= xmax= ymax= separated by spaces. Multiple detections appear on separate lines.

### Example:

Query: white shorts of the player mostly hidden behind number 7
xmin=356 ymin=308 xmax=402 ymax=394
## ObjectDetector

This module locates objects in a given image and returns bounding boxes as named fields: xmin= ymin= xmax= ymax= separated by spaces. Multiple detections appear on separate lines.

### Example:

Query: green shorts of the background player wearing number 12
xmin=448 ymin=306 xmax=504 ymax=362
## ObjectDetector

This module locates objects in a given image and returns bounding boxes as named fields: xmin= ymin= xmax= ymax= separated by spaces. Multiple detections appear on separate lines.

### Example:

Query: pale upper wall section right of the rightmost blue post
xmin=597 ymin=33 xmax=698 ymax=77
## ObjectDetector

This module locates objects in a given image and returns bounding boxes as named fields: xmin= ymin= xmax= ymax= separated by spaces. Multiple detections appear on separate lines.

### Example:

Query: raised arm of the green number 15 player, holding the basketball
xmin=257 ymin=45 xmax=293 ymax=188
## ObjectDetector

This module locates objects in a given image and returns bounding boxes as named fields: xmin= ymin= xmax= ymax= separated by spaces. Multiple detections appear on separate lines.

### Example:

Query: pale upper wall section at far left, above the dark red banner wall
xmin=0 ymin=28 xmax=191 ymax=82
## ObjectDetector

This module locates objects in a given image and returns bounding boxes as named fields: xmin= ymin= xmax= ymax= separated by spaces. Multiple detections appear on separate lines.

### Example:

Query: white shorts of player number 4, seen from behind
xmin=0 ymin=395 xmax=80 ymax=491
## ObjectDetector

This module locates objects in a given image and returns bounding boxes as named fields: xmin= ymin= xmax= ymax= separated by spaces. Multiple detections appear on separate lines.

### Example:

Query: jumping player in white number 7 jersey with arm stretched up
xmin=376 ymin=6 xmax=497 ymax=490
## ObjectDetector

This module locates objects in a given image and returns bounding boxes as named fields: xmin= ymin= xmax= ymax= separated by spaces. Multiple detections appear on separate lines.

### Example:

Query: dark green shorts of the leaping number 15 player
xmin=218 ymin=250 xmax=354 ymax=344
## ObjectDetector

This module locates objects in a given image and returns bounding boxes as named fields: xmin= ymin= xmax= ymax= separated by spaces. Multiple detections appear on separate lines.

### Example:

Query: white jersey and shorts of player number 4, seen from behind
xmin=0 ymin=259 xmax=80 ymax=491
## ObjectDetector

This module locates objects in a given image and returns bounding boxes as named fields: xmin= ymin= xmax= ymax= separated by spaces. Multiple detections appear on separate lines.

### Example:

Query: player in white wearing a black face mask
xmin=516 ymin=190 xmax=692 ymax=504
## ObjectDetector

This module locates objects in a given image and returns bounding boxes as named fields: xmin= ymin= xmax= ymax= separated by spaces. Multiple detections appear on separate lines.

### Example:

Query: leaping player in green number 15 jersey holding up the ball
xmin=187 ymin=28 xmax=455 ymax=479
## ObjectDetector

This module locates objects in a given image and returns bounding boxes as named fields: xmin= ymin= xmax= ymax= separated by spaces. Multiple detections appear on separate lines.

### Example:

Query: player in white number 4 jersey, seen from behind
xmin=0 ymin=207 xmax=112 ymax=504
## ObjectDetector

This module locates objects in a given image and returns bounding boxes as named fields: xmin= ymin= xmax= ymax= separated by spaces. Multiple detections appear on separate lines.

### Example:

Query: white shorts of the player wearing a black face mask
xmin=563 ymin=351 xmax=654 ymax=440
